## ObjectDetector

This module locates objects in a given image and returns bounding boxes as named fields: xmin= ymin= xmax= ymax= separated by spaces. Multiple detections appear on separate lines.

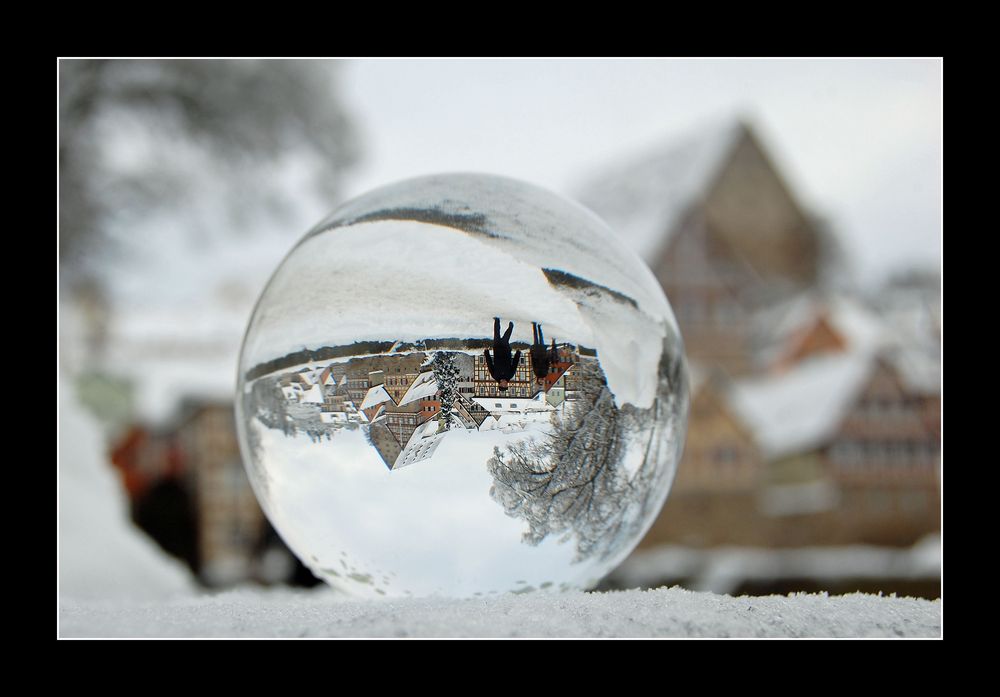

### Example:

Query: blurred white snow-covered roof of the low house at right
xmin=730 ymin=353 xmax=874 ymax=457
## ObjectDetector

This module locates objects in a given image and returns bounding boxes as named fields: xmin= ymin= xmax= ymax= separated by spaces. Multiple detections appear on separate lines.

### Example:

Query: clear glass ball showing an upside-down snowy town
xmin=236 ymin=175 xmax=688 ymax=597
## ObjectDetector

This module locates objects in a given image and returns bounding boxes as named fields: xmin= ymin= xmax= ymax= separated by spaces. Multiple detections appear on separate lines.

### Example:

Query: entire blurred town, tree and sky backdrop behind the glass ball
xmin=58 ymin=60 xmax=943 ymax=598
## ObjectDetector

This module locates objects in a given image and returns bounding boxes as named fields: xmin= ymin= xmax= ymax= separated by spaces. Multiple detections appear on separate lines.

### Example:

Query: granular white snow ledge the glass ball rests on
xmin=59 ymin=587 xmax=941 ymax=637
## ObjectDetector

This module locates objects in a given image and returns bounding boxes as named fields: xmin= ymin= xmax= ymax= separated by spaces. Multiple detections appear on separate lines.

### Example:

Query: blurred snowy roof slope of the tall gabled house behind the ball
xmin=578 ymin=120 xmax=745 ymax=263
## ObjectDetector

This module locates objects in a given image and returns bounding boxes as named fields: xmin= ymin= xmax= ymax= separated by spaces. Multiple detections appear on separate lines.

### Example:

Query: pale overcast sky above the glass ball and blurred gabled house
xmin=340 ymin=60 xmax=943 ymax=286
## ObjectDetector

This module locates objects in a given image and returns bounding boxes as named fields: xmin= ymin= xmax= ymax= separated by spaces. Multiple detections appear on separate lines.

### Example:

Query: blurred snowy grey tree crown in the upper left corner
xmin=59 ymin=60 xmax=358 ymax=282
